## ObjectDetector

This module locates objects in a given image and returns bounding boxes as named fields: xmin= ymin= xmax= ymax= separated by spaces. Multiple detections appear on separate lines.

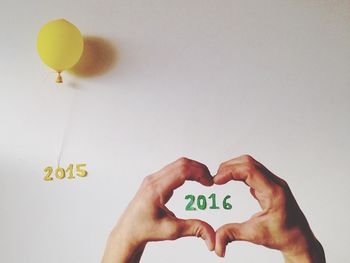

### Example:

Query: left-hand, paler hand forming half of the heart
xmin=102 ymin=158 xmax=215 ymax=263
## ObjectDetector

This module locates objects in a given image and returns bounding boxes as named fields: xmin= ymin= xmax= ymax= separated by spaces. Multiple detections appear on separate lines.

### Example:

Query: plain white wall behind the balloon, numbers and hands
xmin=0 ymin=0 xmax=350 ymax=263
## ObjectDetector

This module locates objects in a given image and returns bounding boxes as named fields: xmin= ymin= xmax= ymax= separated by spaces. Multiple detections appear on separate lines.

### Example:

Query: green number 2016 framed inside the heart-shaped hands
xmin=185 ymin=193 xmax=232 ymax=211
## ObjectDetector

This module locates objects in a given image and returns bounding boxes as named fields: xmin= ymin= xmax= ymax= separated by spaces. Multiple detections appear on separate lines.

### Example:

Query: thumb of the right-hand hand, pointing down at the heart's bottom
xmin=215 ymin=222 xmax=254 ymax=257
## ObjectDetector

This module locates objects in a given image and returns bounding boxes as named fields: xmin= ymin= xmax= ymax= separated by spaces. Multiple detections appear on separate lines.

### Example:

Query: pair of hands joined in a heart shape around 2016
xmin=102 ymin=155 xmax=325 ymax=263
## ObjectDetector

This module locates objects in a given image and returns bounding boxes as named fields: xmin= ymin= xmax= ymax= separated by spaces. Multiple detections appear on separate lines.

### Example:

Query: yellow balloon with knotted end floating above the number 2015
xmin=37 ymin=19 xmax=84 ymax=83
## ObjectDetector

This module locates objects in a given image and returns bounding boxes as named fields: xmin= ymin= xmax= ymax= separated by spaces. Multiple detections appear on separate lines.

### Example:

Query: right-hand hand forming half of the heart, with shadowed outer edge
xmin=214 ymin=155 xmax=326 ymax=263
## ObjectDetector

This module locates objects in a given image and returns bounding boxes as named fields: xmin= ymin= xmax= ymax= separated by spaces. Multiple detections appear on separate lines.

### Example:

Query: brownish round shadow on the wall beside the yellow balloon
xmin=69 ymin=36 xmax=118 ymax=78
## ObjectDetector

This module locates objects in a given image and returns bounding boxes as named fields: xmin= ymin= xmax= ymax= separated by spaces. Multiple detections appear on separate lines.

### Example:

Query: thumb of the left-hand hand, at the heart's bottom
xmin=178 ymin=219 xmax=215 ymax=251
